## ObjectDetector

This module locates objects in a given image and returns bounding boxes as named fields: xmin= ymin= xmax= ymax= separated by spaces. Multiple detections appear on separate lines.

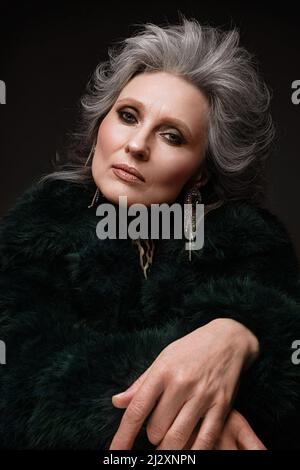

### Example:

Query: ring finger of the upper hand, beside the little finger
xmin=157 ymin=398 xmax=202 ymax=450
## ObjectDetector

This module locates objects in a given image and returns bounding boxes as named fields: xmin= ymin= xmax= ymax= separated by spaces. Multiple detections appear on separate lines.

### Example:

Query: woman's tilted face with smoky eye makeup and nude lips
xmin=92 ymin=72 xmax=209 ymax=206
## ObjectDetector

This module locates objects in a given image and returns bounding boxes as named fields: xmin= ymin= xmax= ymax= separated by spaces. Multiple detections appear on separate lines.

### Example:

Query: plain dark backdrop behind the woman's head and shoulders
xmin=0 ymin=1 xmax=300 ymax=257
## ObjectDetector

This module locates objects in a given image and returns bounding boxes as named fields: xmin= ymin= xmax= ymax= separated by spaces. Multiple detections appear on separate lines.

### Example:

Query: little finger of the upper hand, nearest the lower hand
xmin=191 ymin=405 xmax=226 ymax=450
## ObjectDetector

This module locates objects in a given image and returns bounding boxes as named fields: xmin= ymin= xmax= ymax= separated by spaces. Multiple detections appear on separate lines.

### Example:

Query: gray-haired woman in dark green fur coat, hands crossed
xmin=0 ymin=14 xmax=300 ymax=449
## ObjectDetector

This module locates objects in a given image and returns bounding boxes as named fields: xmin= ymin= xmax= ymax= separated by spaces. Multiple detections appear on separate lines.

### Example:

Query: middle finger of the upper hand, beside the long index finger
xmin=147 ymin=387 xmax=186 ymax=445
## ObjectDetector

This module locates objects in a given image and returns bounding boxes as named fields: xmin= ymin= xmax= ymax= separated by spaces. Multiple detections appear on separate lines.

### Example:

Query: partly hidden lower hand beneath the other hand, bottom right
xmin=214 ymin=410 xmax=267 ymax=450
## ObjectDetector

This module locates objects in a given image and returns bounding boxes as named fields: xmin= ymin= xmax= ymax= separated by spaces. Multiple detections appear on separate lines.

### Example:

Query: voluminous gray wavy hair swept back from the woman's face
xmin=42 ymin=14 xmax=275 ymax=203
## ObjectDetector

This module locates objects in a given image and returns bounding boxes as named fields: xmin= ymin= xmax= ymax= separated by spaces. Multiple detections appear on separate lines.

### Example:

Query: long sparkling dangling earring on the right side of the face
xmin=184 ymin=185 xmax=202 ymax=261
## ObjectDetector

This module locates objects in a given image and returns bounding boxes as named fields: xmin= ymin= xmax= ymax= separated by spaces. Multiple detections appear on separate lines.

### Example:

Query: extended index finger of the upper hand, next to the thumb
xmin=110 ymin=376 xmax=163 ymax=450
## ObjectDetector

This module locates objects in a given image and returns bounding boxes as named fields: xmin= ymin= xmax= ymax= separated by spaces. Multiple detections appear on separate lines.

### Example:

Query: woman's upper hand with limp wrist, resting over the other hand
xmin=110 ymin=318 xmax=258 ymax=450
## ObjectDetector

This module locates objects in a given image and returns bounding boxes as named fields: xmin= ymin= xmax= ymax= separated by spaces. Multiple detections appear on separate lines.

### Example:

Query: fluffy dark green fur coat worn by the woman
xmin=0 ymin=181 xmax=300 ymax=449
